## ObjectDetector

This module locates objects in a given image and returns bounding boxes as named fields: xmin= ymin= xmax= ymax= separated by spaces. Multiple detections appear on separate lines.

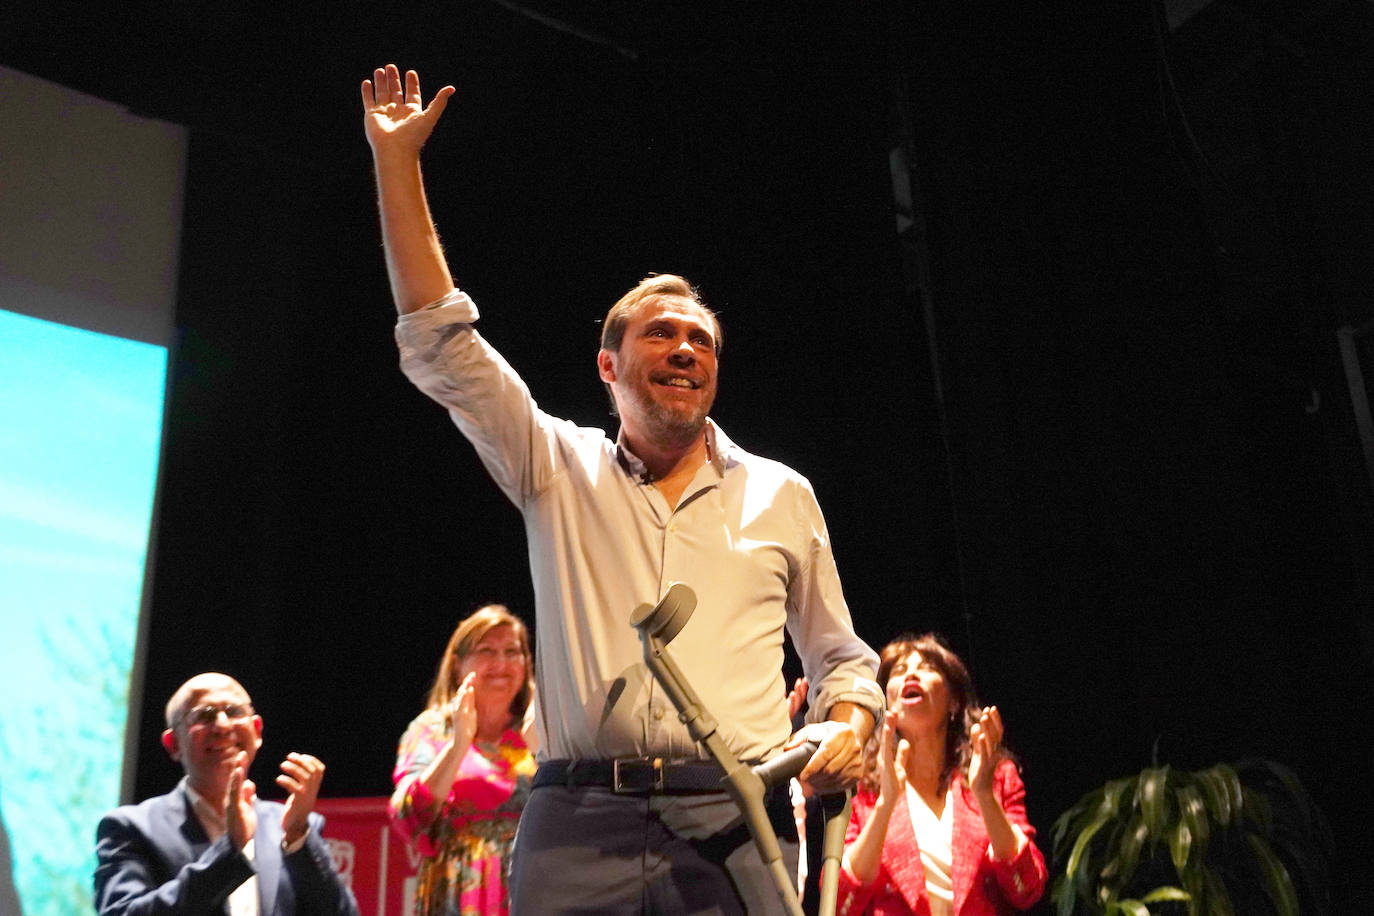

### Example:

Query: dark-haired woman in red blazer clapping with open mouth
xmin=837 ymin=633 xmax=1047 ymax=916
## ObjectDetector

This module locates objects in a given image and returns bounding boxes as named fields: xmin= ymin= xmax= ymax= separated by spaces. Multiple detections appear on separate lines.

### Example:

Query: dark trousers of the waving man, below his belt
xmin=510 ymin=784 xmax=797 ymax=916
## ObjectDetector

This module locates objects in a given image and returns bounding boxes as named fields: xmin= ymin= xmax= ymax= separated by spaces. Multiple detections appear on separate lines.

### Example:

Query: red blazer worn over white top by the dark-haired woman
xmin=835 ymin=761 xmax=1048 ymax=916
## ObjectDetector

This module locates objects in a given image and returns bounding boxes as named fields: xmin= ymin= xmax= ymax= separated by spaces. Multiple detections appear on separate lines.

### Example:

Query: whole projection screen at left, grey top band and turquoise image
xmin=0 ymin=67 xmax=185 ymax=916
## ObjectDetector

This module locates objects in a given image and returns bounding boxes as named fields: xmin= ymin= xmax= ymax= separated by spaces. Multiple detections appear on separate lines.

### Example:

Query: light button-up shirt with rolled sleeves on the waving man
xmin=396 ymin=290 xmax=883 ymax=761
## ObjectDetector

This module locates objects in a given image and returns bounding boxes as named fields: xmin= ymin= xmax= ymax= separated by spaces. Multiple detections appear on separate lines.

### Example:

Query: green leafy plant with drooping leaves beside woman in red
xmin=1051 ymin=759 xmax=1333 ymax=916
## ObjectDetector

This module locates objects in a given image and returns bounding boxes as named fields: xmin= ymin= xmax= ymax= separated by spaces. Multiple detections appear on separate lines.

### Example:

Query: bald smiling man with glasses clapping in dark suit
xmin=95 ymin=673 xmax=357 ymax=916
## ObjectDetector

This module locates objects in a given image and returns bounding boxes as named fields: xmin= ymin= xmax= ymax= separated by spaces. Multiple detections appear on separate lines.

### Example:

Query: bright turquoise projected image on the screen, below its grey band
xmin=0 ymin=310 xmax=168 ymax=916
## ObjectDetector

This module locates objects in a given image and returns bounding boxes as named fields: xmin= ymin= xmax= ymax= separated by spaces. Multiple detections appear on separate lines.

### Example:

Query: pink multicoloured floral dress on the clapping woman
xmin=390 ymin=710 xmax=534 ymax=916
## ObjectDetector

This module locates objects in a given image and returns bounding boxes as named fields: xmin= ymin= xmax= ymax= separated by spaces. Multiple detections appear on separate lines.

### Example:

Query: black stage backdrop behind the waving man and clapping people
xmin=0 ymin=0 xmax=1374 ymax=912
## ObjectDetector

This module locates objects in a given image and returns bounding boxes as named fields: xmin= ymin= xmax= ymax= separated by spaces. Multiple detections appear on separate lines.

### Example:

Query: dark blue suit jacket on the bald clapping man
xmin=95 ymin=780 xmax=357 ymax=916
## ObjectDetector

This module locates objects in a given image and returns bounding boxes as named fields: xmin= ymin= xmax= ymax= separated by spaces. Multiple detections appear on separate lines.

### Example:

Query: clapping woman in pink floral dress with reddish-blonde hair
xmin=390 ymin=604 xmax=534 ymax=916
